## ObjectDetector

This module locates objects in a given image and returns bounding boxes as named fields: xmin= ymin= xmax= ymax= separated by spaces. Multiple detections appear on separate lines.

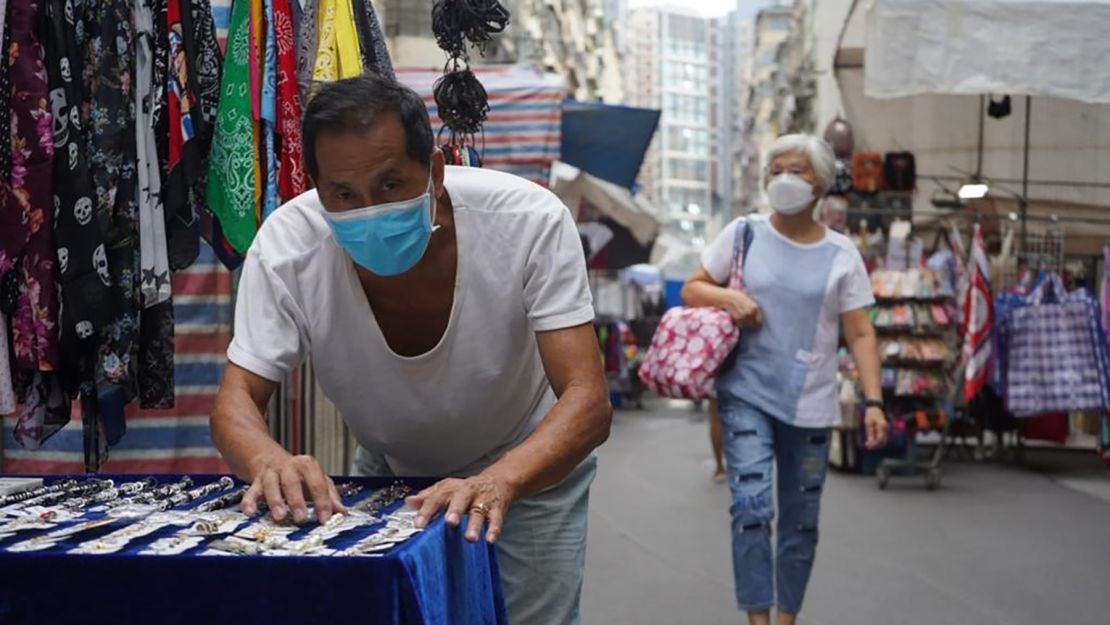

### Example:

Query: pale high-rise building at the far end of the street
xmin=625 ymin=7 xmax=731 ymax=245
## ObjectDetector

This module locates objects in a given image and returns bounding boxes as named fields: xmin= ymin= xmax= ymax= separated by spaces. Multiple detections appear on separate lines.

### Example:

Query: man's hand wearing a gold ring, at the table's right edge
xmin=406 ymin=473 xmax=516 ymax=544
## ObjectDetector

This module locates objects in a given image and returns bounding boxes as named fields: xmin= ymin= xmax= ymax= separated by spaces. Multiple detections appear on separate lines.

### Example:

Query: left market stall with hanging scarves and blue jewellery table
xmin=0 ymin=0 xmax=519 ymax=623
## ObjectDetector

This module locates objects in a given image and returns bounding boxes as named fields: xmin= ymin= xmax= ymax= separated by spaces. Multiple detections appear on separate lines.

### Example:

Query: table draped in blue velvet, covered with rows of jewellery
xmin=0 ymin=475 xmax=507 ymax=625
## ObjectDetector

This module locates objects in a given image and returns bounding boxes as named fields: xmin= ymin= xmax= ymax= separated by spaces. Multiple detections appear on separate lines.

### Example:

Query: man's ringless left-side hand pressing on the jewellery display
xmin=242 ymin=453 xmax=345 ymax=525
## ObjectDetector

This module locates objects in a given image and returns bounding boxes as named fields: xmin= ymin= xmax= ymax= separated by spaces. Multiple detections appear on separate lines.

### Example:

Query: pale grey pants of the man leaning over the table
xmin=352 ymin=447 xmax=597 ymax=625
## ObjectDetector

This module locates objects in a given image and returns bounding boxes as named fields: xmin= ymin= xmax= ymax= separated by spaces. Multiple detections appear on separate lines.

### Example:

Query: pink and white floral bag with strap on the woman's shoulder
xmin=639 ymin=221 xmax=753 ymax=401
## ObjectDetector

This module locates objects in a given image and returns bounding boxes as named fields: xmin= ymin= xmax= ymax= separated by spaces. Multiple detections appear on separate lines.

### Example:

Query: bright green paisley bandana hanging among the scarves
xmin=206 ymin=0 xmax=258 ymax=254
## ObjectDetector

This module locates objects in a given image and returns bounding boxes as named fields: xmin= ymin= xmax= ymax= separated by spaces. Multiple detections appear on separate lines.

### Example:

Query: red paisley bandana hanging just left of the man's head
xmin=273 ymin=0 xmax=307 ymax=201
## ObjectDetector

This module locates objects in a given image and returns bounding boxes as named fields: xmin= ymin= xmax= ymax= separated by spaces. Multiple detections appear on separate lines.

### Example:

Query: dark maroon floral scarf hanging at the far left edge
xmin=0 ymin=0 xmax=58 ymax=386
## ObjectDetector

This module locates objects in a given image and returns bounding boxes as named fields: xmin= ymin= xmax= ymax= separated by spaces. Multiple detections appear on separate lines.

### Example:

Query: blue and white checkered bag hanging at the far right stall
xmin=1006 ymin=290 xmax=1110 ymax=417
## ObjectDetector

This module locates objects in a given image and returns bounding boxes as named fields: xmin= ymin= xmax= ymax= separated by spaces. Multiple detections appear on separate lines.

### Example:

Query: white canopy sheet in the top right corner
xmin=865 ymin=0 xmax=1110 ymax=102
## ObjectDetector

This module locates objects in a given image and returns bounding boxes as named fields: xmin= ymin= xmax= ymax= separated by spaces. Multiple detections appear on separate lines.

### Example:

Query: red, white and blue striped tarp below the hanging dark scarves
xmin=0 ymin=243 xmax=232 ymax=474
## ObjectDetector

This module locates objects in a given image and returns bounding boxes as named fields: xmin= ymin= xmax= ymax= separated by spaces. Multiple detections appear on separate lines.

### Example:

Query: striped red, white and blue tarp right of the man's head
xmin=396 ymin=65 xmax=566 ymax=187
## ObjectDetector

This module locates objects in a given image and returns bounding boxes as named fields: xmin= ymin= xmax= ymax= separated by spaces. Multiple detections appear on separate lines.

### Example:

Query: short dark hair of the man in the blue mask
xmin=301 ymin=73 xmax=435 ymax=179
